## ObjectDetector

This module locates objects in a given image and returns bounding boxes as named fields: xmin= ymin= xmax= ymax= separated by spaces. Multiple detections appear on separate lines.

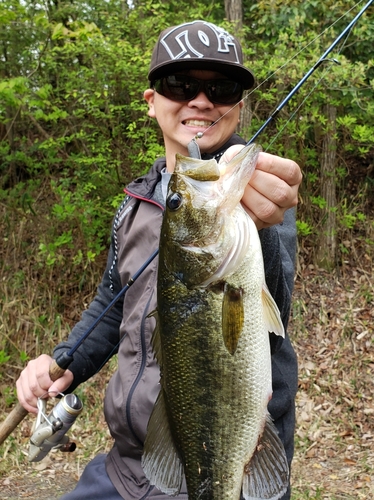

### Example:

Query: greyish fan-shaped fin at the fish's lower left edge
xmin=142 ymin=389 xmax=183 ymax=496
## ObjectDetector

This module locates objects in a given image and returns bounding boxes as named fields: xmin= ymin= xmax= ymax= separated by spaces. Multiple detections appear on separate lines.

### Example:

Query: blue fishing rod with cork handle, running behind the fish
xmin=0 ymin=0 xmax=374 ymax=445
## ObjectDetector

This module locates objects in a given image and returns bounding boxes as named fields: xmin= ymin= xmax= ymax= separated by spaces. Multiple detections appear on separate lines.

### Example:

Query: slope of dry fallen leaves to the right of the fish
xmin=289 ymin=263 xmax=374 ymax=500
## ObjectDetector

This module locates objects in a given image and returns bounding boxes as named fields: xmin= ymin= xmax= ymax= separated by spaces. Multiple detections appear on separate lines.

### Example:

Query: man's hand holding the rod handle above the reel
xmin=16 ymin=354 xmax=74 ymax=413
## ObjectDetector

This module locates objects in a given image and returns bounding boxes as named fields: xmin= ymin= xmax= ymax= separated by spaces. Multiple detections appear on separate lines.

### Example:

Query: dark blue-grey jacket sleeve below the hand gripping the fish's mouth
xmin=259 ymin=208 xmax=297 ymax=352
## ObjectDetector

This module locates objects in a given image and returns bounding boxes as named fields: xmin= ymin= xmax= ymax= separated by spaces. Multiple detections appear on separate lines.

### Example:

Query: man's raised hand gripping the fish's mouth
xmin=221 ymin=144 xmax=302 ymax=229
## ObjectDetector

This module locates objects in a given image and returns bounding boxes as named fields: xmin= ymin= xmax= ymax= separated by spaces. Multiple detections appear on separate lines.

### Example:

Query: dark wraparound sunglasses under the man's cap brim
xmin=153 ymin=75 xmax=243 ymax=104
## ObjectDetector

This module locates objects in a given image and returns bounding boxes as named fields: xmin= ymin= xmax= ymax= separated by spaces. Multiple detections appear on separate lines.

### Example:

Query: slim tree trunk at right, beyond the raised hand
xmin=316 ymin=104 xmax=337 ymax=270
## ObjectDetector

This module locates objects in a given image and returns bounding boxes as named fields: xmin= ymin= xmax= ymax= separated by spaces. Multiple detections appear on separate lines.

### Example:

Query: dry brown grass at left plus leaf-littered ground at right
xmin=0 ymin=200 xmax=374 ymax=500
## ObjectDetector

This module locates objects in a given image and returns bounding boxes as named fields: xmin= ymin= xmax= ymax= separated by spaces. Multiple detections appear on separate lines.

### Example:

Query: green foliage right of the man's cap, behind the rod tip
xmin=238 ymin=0 xmax=374 ymax=260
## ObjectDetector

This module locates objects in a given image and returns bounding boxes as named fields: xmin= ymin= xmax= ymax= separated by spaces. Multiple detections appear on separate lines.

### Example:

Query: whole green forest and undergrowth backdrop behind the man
xmin=0 ymin=0 xmax=374 ymax=498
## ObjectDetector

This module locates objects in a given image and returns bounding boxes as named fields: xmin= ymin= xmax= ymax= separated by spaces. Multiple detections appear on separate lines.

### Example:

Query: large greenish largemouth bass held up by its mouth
xmin=142 ymin=145 xmax=288 ymax=500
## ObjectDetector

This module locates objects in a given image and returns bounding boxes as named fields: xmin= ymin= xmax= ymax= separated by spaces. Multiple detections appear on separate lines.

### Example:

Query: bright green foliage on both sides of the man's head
xmin=0 ymin=0 xmax=374 ymax=274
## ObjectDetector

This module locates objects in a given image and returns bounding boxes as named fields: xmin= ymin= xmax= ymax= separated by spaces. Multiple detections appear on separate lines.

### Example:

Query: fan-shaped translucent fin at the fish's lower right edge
xmin=243 ymin=414 xmax=289 ymax=500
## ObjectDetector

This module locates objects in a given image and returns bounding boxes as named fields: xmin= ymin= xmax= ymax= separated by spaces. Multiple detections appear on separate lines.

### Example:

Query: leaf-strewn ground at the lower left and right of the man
xmin=0 ymin=267 xmax=374 ymax=500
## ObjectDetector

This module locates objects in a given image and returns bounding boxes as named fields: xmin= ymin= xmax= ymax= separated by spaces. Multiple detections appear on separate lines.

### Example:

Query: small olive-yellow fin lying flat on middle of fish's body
xmin=222 ymin=283 xmax=244 ymax=355
